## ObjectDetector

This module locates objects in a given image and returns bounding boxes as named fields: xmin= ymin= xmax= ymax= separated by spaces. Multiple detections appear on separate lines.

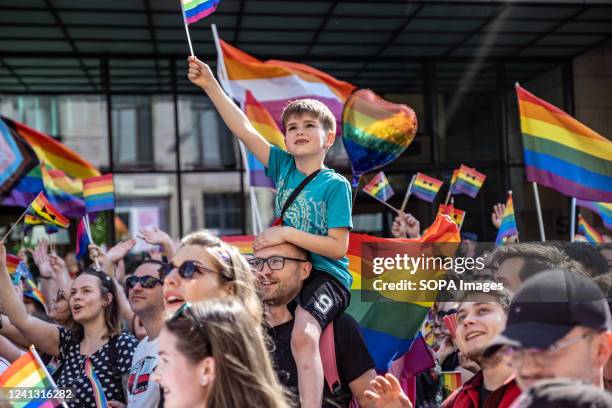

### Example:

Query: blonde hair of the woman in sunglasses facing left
xmin=179 ymin=230 xmax=263 ymax=324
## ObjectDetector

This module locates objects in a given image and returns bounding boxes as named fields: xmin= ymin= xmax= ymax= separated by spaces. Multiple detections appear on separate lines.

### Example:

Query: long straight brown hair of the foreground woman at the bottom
xmin=166 ymin=297 xmax=289 ymax=408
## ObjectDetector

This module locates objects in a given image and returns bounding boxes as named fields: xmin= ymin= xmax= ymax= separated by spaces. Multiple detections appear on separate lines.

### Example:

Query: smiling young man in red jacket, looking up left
xmin=442 ymin=289 xmax=520 ymax=408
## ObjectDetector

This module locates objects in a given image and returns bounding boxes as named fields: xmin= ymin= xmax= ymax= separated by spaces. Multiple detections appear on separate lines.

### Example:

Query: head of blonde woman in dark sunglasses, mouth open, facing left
xmin=164 ymin=231 xmax=262 ymax=324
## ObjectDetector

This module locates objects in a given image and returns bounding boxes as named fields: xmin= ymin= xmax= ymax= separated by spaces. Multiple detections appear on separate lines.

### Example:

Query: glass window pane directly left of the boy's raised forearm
xmin=178 ymin=96 xmax=239 ymax=170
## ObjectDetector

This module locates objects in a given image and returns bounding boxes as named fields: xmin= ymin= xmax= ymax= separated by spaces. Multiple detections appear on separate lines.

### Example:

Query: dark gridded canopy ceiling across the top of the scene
xmin=0 ymin=0 xmax=612 ymax=93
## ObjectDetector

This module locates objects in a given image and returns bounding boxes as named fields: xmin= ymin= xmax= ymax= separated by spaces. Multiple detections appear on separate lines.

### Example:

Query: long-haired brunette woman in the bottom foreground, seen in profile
xmin=154 ymin=297 xmax=288 ymax=408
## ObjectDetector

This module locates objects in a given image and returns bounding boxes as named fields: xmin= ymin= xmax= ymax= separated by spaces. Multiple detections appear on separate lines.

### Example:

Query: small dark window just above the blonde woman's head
xmin=203 ymin=193 xmax=242 ymax=235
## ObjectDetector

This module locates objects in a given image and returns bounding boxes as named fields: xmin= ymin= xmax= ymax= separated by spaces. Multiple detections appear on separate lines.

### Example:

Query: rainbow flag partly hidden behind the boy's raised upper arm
xmin=242 ymin=91 xmax=287 ymax=188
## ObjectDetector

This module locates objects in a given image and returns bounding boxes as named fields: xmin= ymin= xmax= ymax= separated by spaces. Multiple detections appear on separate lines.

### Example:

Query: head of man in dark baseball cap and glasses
xmin=485 ymin=270 xmax=612 ymax=390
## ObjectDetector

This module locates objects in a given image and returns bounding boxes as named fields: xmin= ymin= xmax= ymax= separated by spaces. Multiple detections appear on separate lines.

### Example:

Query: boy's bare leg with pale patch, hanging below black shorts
xmin=291 ymin=306 xmax=325 ymax=408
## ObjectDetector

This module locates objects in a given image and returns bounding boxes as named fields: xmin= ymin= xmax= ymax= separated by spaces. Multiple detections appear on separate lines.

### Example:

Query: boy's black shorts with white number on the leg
xmin=295 ymin=269 xmax=351 ymax=330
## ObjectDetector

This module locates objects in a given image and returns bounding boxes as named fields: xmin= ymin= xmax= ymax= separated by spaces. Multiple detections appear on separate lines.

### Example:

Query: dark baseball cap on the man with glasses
xmin=485 ymin=270 xmax=611 ymax=355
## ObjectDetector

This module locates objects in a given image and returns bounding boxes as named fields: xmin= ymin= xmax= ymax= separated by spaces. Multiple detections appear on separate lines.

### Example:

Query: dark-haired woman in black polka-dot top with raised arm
xmin=0 ymin=243 xmax=137 ymax=408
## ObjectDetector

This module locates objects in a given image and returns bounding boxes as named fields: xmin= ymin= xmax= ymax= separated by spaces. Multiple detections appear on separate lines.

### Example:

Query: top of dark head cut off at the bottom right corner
xmin=515 ymin=378 xmax=612 ymax=408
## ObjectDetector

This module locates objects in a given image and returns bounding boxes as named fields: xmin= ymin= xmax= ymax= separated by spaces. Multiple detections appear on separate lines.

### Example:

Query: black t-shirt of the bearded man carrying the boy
xmin=268 ymin=313 xmax=374 ymax=408
